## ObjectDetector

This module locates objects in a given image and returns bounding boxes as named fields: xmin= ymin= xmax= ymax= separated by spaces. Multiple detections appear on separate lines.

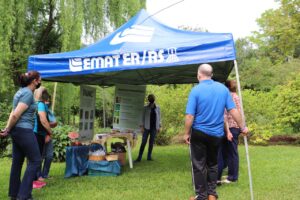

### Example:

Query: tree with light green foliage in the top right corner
xmin=252 ymin=0 xmax=300 ymax=63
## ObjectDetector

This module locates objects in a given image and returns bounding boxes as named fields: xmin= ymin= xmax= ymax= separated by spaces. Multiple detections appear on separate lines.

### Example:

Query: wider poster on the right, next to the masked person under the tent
xmin=113 ymin=85 xmax=146 ymax=132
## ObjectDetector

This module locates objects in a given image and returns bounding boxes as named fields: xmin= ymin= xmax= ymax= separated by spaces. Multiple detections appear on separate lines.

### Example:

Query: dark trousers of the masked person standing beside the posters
xmin=137 ymin=129 xmax=156 ymax=160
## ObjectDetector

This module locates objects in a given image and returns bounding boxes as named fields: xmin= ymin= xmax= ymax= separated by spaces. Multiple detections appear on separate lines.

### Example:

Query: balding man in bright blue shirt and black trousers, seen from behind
xmin=184 ymin=64 xmax=248 ymax=200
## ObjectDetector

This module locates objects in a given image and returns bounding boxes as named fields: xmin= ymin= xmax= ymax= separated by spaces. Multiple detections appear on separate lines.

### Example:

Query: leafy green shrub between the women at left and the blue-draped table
xmin=52 ymin=125 xmax=75 ymax=162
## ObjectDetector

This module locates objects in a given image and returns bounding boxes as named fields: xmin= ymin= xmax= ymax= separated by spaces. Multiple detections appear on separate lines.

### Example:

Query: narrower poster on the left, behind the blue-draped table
xmin=79 ymin=85 xmax=96 ymax=141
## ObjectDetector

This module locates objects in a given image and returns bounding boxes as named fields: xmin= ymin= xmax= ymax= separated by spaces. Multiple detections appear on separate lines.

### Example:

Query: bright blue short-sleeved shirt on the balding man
xmin=186 ymin=80 xmax=235 ymax=137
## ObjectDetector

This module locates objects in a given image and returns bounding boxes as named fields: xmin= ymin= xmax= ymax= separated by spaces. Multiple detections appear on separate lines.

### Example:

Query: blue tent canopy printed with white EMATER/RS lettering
xmin=28 ymin=10 xmax=236 ymax=85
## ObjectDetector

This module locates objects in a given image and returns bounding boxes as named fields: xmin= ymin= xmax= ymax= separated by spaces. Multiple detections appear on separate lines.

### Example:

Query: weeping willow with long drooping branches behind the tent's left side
xmin=0 ymin=0 xmax=145 ymax=122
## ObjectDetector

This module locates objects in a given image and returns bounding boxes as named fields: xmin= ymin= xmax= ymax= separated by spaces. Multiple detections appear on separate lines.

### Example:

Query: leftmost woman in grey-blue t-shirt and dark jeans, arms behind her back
xmin=2 ymin=71 xmax=41 ymax=200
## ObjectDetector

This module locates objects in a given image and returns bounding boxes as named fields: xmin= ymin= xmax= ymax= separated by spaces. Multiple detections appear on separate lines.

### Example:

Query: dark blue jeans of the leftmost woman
xmin=9 ymin=127 xmax=41 ymax=200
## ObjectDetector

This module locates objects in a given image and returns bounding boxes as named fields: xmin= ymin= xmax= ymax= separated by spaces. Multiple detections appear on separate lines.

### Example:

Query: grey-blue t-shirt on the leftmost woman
xmin=13 ymin=87 xmax=36 ymax=129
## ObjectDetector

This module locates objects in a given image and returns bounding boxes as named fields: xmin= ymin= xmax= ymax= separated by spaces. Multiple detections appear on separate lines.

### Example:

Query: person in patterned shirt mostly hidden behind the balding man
xmin=218 ymin=80 xmax=241 ymax=183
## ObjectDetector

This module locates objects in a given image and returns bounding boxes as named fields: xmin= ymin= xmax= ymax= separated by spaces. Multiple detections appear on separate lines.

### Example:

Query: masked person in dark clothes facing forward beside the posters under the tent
xmin=135 ymin=94 xmax=161 ymax=162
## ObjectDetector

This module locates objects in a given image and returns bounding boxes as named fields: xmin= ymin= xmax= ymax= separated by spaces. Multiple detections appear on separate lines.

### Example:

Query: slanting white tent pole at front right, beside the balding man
xmin=234 ymin=60 xmax=254 ymax=200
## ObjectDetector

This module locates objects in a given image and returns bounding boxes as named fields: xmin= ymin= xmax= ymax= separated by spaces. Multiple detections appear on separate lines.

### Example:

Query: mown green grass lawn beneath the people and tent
xmin=0 ymin=145 xmax=300 ymax=200
